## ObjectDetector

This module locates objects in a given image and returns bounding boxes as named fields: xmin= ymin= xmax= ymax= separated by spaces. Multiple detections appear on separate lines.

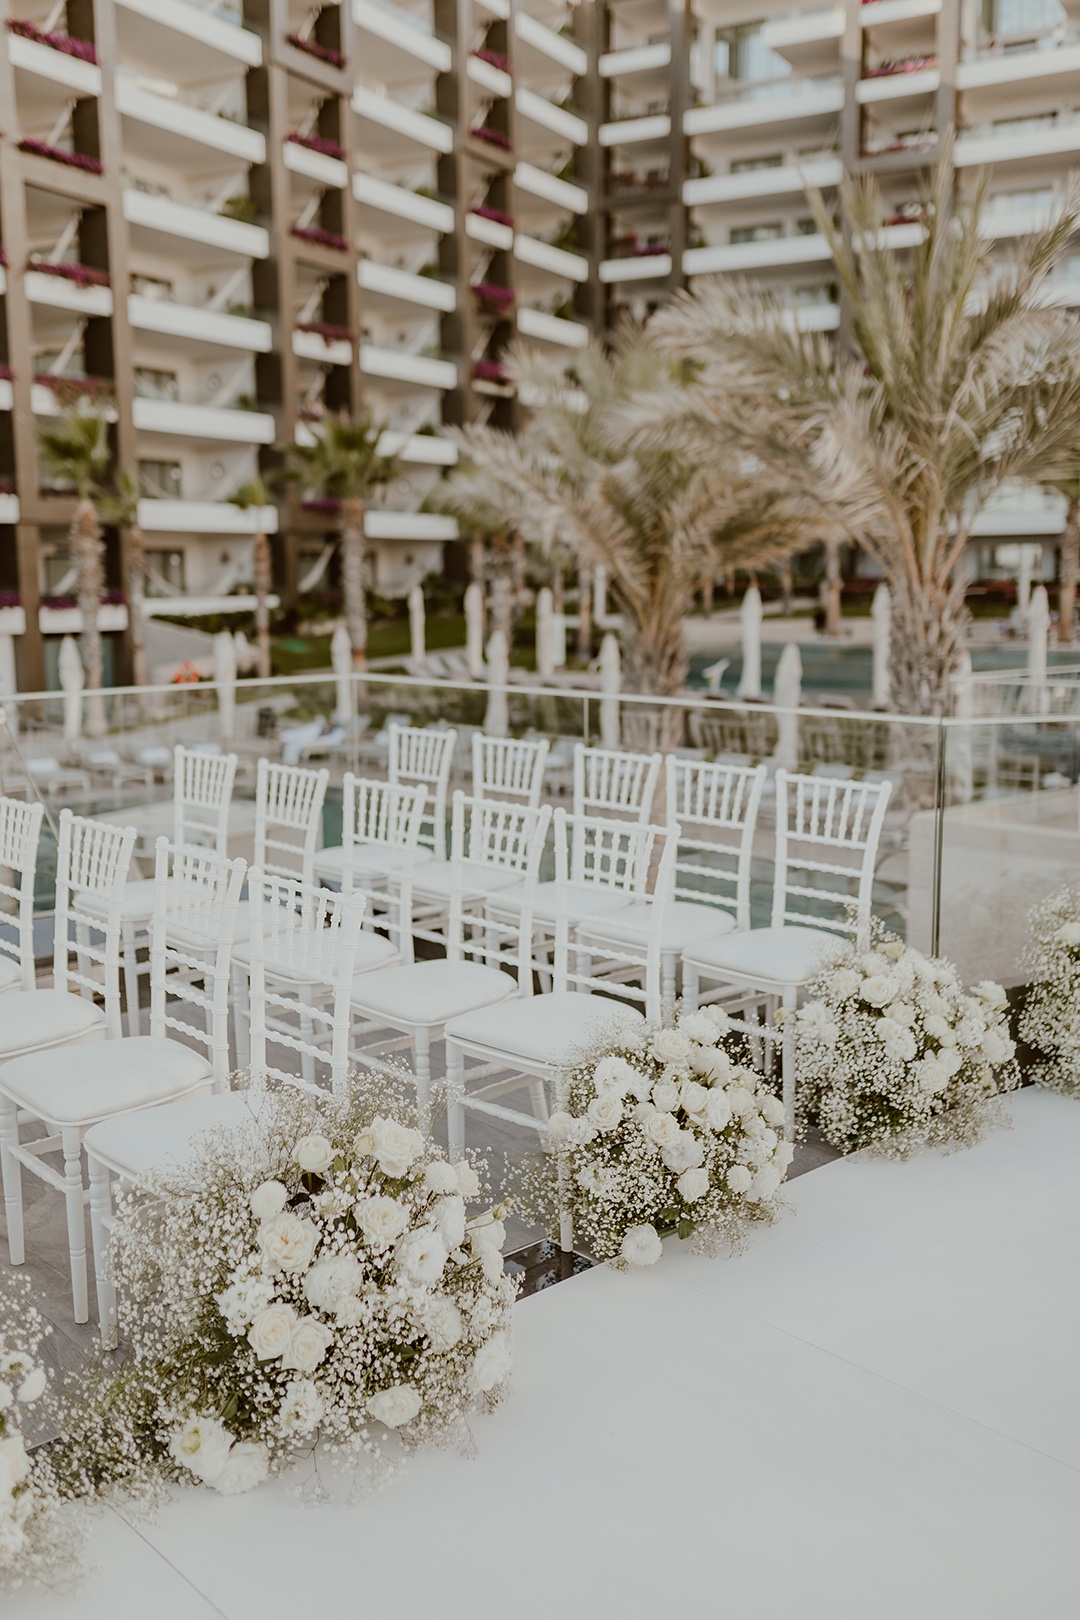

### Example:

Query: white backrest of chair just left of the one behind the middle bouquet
xmin=446 ymin=792 xmax=551 ymax=996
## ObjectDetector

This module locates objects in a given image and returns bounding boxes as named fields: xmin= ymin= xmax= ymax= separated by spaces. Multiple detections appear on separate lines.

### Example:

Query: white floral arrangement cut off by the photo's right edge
xmin=1020 ymin=889 xmax=1080 ymax=1097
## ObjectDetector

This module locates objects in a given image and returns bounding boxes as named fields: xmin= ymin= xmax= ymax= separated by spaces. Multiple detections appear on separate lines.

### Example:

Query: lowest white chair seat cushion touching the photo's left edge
xmin=0 ymin=1036 xmax=212 ymax=1124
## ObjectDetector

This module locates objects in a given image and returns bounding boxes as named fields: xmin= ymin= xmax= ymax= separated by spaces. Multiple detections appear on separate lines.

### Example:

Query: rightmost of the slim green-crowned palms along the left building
xmin=278 ymin=415 xmax=397 ymax=669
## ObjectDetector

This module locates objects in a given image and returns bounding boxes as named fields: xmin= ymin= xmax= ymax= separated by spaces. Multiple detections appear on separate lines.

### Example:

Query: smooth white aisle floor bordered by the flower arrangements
xmin=3 ymin=1090 xmax=1080 ymax=1620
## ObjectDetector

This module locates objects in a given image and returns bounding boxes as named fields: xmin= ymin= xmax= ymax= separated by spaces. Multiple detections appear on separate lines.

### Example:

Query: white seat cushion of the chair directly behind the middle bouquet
xmin=444 ymin=990 xmax=644 ymax=1069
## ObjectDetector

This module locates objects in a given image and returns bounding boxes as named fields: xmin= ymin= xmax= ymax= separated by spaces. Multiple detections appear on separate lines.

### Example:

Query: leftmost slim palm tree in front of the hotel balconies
xmin=37 ymin=403 xmax=112 ymax=690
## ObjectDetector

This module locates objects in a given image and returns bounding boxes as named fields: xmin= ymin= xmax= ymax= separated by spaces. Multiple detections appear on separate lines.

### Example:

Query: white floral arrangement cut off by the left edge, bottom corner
xmin=0 ymin=1272 xmax=81 ymax=1592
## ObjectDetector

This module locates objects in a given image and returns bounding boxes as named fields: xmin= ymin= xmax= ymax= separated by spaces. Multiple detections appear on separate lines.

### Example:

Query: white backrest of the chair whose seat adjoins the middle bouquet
xmin=552 ymin=808 xmax=680 ymax=1022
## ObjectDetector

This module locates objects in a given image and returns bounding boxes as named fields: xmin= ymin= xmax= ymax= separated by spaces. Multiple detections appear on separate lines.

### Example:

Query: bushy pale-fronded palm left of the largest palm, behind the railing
xmin=432 ymin=326 xmax=803 ymax=738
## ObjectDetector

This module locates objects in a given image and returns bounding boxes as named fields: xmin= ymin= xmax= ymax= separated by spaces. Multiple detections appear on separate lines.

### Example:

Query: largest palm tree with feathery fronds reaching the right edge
xmin=647 ymin=151 xmax=1080 ymax=714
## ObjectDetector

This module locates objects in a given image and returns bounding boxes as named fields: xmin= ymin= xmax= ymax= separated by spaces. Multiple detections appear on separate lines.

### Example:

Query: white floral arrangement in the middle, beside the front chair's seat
xmin=521 ymin=1008 xmax=793 ymax=1267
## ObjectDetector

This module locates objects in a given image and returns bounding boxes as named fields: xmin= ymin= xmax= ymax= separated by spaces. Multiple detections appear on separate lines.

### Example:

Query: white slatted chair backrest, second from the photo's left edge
xmin=52 ymin=810 xmax=138 ymax=1040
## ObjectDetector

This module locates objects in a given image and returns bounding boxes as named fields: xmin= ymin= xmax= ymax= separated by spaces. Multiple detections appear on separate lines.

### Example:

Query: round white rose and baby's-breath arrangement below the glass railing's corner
xmin=795 ymin=928 xmax=1020 ymax=1158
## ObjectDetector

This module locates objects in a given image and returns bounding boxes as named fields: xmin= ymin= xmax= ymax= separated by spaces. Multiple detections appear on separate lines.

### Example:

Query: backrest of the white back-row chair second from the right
xmin=667 ymin=753 xmax=767 ymax=928
